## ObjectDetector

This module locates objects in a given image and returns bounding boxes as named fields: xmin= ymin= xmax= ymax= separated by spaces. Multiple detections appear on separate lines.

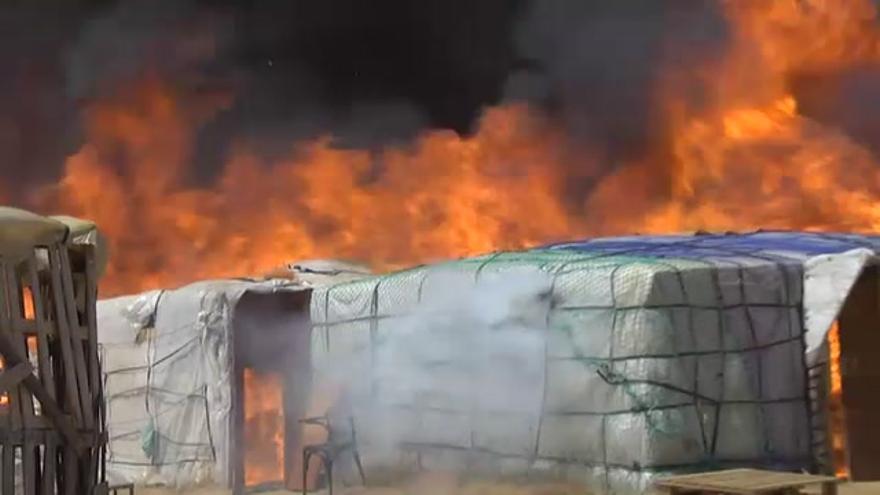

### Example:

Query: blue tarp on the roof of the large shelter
xmin=545 ymin=231 xmax=880 ymax=261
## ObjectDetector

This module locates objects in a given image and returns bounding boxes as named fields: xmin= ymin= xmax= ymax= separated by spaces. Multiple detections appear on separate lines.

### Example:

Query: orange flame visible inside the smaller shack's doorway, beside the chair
xmin=244 ymin=368 xmax=284 ymax=486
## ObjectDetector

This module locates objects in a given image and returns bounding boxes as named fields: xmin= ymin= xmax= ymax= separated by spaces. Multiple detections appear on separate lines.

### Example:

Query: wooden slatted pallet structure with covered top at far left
xmin=0 ymin=212 xmax=106 ymax=495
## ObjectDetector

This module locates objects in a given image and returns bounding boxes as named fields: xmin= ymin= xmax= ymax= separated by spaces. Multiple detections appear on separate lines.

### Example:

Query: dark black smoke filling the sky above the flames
xmin=0 ymin=0 xmax=880 ymax=202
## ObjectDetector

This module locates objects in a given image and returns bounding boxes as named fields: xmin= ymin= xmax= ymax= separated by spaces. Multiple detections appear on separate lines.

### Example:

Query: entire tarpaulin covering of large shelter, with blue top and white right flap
xmin=311 ymin=233 xmax=880 ymax=493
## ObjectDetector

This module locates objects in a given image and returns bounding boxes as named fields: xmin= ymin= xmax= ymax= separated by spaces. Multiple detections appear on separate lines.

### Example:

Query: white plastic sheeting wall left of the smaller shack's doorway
xmin=98 ymin=285 xmax=241 ymax=486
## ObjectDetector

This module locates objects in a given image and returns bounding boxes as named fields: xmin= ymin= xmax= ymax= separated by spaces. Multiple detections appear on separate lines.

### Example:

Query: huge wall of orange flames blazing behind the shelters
xmin=22 ymin=0 xmax=880 ymax=295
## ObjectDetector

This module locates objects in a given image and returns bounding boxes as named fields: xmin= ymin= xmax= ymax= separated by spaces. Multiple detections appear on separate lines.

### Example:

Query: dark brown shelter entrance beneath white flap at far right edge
xmin=838 ymin=266 xmax=880 ymax=481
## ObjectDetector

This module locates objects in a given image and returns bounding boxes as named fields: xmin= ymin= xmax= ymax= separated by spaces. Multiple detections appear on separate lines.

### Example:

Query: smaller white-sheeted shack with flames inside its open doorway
xmin=97 ymin=261 xmax=365 ymax=492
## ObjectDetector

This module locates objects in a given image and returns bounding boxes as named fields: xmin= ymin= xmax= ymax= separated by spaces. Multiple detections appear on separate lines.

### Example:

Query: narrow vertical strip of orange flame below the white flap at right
xmin=828 ymin=321 xmax=849 ymax=479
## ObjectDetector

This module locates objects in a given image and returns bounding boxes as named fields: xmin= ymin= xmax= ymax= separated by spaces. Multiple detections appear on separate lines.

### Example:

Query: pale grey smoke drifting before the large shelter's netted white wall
xmin=316 ymin=269 xmax=552 ymax=459
